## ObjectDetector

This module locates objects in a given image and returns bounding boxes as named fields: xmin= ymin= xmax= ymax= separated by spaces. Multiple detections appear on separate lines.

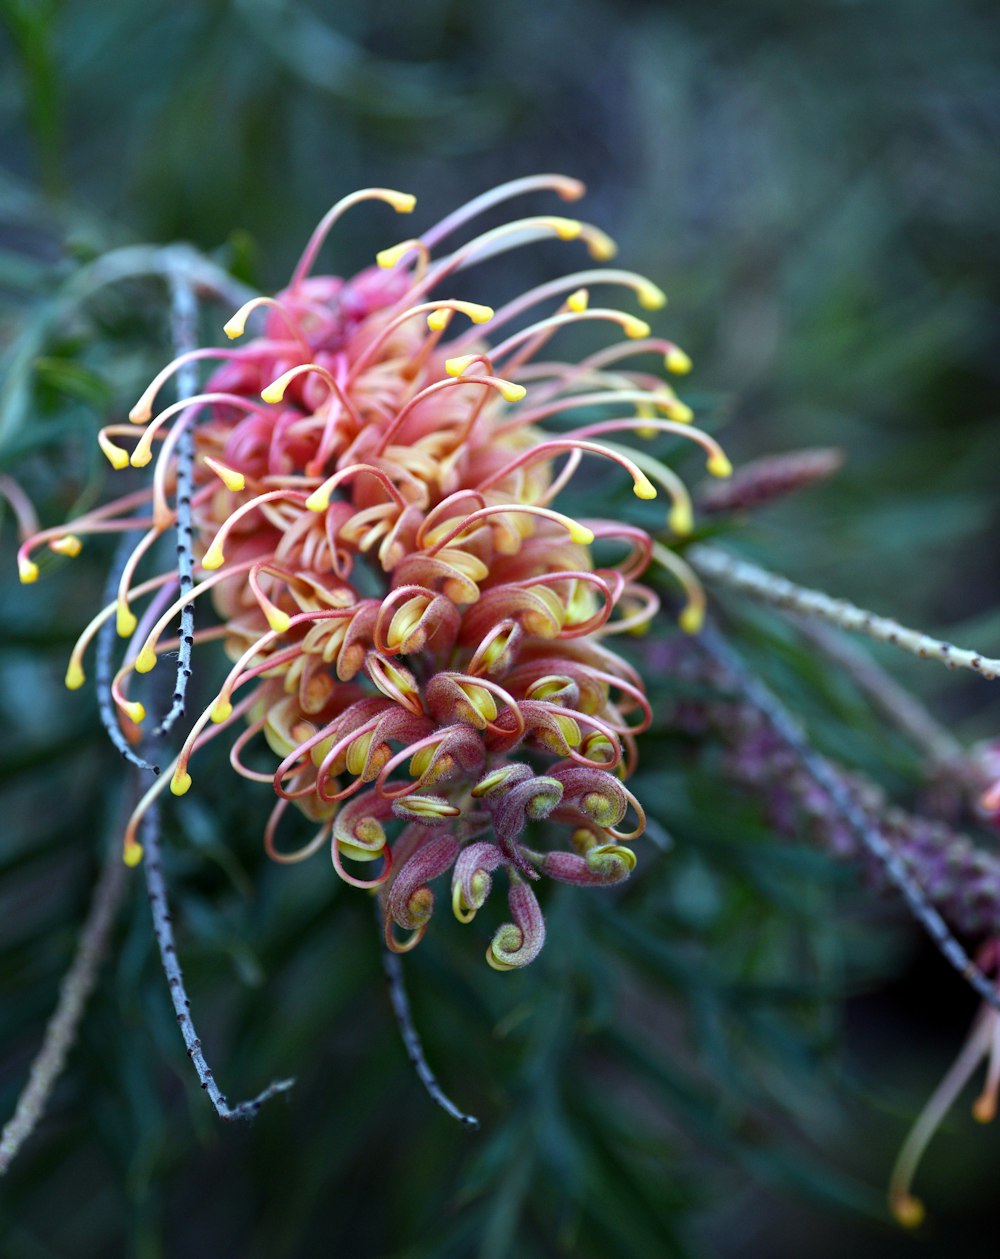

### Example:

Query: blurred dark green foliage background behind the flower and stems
xmin=0 ymin=0 xmax=1000 ymax=1259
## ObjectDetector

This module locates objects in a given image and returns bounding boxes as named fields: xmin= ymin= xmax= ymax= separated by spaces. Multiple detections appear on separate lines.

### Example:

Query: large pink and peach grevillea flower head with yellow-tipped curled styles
xmin=20 ymin=176 xmax=729 ymax=971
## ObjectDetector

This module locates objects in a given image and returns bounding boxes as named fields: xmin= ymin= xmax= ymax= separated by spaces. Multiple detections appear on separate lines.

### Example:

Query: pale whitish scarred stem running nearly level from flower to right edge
xmin=684 ymin=543 xmax=1000 ymax=681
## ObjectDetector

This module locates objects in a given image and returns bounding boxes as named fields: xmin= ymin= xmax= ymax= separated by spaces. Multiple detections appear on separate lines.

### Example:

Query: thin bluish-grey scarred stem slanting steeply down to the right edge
xmin=696 ymin=624 xmax=1000 ymax=1011
